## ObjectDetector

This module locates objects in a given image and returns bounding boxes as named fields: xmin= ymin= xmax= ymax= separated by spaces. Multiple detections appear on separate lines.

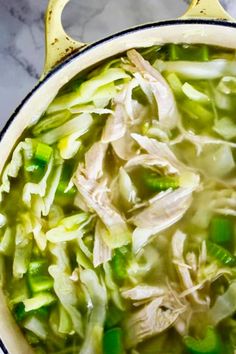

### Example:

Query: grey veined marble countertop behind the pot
xmin=0 ymin=0 xmax=236 ymax=128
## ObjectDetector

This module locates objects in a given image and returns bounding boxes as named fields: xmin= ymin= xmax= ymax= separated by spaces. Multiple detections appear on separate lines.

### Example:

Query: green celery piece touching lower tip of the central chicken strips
xmin=111 ymin=247 xmax=129 ymax=282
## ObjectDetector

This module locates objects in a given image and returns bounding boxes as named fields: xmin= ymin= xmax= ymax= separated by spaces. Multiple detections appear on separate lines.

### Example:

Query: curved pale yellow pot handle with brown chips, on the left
xmin=43 ymin=0 xmax=86 ymax=77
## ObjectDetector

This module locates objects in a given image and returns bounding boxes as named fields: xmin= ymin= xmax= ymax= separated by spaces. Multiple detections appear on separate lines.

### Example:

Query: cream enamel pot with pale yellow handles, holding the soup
xmin=0 ymin=0 xmax=236 ymax=354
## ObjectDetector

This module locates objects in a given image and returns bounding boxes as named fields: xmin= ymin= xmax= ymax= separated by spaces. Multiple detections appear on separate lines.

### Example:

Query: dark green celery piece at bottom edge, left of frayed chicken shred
xmin=103 ymin=327 xmax=124 ymax=354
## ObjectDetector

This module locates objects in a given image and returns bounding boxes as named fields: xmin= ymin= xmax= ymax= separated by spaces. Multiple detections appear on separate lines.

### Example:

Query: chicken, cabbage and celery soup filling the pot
xmin=0 ymin=44 xmax=236 ymax=354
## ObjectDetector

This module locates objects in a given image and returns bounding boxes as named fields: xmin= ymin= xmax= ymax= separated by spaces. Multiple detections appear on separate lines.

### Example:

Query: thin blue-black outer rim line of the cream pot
xmin=0 ymin=18 xmax=236 ymax=142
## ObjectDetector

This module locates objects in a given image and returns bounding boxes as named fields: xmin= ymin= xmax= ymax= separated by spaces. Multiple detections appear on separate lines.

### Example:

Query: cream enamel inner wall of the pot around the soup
xmin=0 ymin=22 xmax=236 ymax=354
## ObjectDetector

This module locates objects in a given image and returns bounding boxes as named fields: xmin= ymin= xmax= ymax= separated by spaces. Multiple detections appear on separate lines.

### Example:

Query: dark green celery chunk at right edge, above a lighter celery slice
xmin=210 ymin=216 xmax=234 ymax=244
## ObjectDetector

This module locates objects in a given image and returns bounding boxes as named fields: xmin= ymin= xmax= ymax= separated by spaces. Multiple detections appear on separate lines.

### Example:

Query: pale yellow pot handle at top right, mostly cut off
xmin=181 ymin=0 xmax=235 ymax=21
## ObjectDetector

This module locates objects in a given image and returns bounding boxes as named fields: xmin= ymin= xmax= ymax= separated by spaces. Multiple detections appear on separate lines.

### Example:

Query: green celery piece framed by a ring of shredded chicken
xmin=143 ymin=171 xmax=179 ymax=191
